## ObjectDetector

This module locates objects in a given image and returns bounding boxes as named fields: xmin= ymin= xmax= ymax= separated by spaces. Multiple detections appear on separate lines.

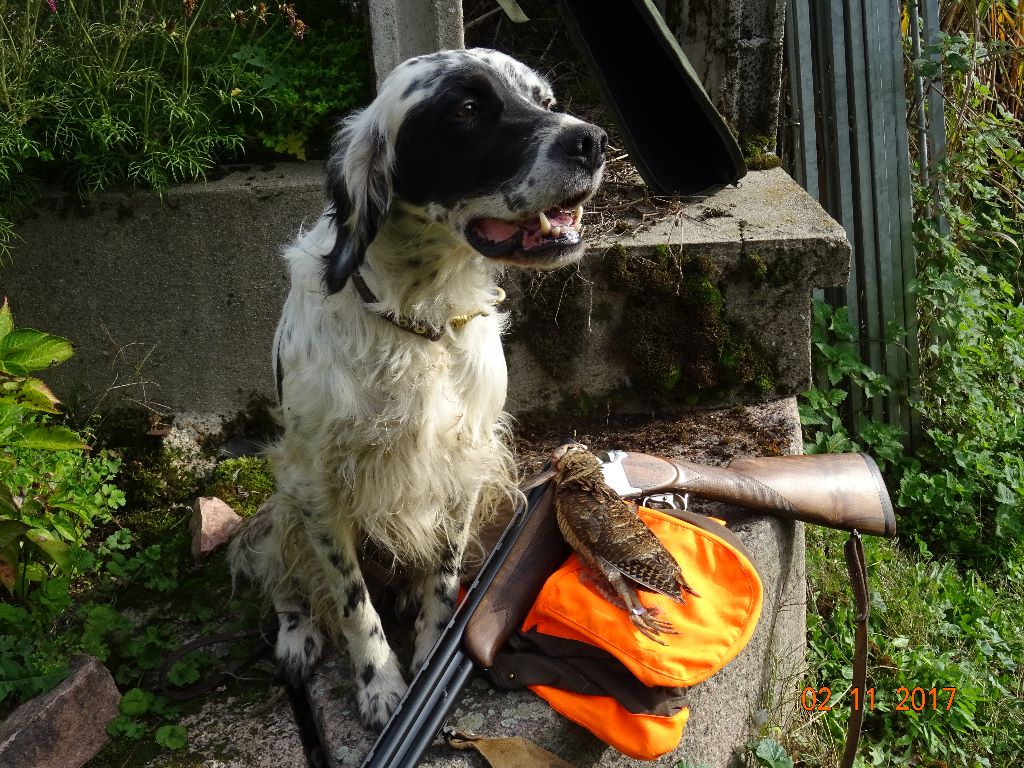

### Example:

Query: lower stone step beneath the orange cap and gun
xmin=311 ymin=398 xmax=805 ymax=768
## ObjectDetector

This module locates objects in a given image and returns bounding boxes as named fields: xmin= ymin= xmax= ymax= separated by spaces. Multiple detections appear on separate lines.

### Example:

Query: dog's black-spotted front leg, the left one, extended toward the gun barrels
xmin=311 ymin=531 xmax=407 ymax=730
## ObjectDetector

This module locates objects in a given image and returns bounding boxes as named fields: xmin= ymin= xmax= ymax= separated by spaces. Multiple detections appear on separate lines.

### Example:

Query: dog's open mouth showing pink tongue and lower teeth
xmin=466 ymin=205 xmax=583 ymax=258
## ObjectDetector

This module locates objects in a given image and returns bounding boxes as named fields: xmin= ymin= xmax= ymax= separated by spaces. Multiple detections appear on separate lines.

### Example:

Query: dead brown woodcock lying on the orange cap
xmin=551 ymin=444 xmax=699 ymax=645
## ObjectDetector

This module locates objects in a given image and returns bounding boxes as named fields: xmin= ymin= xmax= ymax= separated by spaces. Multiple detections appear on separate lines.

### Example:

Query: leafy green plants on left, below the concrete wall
xmin=0 ymin=303 xmax=271 ymax=752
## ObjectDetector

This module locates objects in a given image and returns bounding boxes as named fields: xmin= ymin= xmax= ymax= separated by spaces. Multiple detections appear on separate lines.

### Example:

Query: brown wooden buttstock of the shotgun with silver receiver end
xmin=605 ymin=453 xmax=896 ymax=538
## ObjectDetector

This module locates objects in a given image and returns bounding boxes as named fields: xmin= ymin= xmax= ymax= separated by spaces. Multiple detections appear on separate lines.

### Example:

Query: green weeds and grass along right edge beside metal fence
xmin=784 ymin=19 xmax=1024 ymax=768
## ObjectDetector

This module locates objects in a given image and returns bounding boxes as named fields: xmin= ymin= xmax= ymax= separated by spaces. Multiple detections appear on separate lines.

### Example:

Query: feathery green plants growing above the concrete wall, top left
xmin=0 ymin=0 xmax=369 ymax=260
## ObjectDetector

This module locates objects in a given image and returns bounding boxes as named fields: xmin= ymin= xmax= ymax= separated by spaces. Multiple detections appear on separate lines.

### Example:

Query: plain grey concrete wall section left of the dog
xmin=0 ymin=164 xmax=325 ymax=413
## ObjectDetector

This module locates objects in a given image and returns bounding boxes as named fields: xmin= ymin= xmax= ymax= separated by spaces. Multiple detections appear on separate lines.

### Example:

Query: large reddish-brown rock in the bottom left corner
xmin=0 ymin=656 xmax=121 ymax=768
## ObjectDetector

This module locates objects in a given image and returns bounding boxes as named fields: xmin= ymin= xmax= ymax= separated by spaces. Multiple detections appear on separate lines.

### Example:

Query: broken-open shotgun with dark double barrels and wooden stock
xmin=361 ymin=452 xmax=896 ymax=768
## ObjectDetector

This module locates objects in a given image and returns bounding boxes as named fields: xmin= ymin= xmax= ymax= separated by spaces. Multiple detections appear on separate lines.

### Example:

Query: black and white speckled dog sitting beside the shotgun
xmin=231 ymin=49 xmax=606 ymax=728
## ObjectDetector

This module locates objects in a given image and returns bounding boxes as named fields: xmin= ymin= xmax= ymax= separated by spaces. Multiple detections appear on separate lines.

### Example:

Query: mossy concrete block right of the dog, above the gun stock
xmin=506 ymin=169 xmax=850 ymax=414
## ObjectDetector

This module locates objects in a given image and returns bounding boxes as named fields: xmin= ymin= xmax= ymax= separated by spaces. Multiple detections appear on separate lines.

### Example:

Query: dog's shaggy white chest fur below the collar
xmin=275 ymin=217 xmax=510 ymax=565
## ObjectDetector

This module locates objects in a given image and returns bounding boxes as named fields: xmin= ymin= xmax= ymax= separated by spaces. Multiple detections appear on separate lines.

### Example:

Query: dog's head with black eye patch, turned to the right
xmin=325 ymin=48 xmax=607 ymax=292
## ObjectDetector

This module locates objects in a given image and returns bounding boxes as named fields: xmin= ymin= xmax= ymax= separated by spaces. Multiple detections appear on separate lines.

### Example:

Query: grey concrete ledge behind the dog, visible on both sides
xmin=0 ymin=163 xmax=849 ymax=415
